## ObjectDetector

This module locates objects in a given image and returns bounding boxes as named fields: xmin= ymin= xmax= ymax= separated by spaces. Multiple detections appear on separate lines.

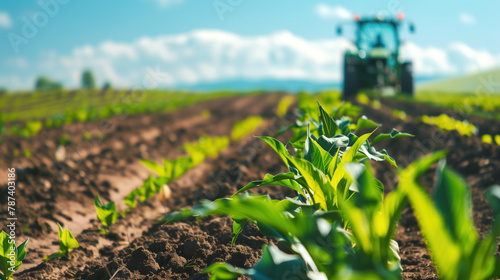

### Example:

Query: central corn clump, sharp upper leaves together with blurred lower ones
xmin=166 ymin=103 xmax=410 ymax=279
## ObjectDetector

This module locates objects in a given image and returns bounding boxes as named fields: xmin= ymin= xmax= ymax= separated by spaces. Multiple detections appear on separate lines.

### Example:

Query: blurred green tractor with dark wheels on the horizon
xmin=337 ymin=13 xmax=415 ymax=98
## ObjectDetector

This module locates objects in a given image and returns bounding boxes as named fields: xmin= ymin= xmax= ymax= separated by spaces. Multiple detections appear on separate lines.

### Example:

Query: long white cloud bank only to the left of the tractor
xmin=41 ymin=30 xmax=351 ymax=86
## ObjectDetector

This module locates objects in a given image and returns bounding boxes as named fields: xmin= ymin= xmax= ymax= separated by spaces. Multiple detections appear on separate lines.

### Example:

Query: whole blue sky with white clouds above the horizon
xmin=0 ymin=0 xmax=500 ymax=90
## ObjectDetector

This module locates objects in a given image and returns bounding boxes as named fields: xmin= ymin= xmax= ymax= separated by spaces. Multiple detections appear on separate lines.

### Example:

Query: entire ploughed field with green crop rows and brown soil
xmin=0 ymin=91 xmax=500 ymax=279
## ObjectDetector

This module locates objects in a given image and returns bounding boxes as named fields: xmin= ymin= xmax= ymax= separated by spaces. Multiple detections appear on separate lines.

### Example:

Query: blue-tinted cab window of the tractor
xmin=357 ymin=22 xmax=397 ymax=54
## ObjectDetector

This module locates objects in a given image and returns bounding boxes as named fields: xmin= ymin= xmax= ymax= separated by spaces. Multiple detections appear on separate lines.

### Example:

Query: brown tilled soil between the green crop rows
xmin=0 ymin=94 xmax=500 ymax=279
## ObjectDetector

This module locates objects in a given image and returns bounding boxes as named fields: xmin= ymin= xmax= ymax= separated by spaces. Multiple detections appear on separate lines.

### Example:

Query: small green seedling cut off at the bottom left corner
xmin=0 ymin=230 xmax=29 ymax=280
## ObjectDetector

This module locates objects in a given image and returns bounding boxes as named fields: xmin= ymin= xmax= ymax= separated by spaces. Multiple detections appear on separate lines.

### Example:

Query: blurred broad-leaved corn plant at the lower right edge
xmin=399 ymin=152 xmax=500 ymax=280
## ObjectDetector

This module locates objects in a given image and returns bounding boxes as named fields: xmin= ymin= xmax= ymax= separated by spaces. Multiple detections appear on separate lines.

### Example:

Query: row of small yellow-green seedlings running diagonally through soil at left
xmin=0 ymin=113 xmax=264 ymax=280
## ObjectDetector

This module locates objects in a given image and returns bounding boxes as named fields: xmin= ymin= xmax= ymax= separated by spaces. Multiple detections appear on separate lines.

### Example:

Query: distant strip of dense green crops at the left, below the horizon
xmin=0 ymin=91 xmax=242 ymax=143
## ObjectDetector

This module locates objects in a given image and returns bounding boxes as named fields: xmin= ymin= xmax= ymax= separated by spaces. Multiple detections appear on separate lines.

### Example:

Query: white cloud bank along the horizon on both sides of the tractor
xmin=0 ymin=30 xmax=500 ymax=88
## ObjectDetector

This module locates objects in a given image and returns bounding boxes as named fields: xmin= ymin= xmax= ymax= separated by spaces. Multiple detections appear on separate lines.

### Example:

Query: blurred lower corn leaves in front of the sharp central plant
xmin=169 ymin=160 xmax=406 ymax=280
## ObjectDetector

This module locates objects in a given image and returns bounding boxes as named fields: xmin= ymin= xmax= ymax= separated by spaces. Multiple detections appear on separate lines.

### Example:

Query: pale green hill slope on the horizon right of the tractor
xmin=418 ymin=69 xmax=500 ymax=93
